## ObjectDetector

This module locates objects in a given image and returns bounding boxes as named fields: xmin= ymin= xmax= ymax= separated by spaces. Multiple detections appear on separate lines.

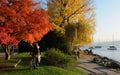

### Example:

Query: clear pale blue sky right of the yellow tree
xmin=94 ymin=0 xmax=120 ymax=42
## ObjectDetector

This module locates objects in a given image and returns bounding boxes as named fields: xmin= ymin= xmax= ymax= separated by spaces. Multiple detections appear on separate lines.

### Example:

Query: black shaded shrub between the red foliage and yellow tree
xmin=38 ymin=30 xmax=67 ymax=52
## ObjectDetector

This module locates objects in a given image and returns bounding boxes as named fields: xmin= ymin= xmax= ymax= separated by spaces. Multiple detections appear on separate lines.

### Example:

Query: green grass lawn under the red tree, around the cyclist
xmin=0 ymin=53 xmax=87 ymax=75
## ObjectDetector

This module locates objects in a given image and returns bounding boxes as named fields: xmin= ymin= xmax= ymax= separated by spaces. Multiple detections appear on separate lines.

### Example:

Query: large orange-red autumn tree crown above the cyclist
xmin=0 ymin=0 xmax=52 ymax=59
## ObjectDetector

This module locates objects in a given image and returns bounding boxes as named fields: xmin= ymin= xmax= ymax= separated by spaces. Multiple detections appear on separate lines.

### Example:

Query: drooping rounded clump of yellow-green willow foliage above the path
xmin=65 ymin=20 xmax=94 ymax=47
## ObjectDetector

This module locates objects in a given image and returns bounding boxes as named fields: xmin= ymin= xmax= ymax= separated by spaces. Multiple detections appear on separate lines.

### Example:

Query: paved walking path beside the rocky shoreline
xmin=77 ymin=55 xmax=120 ymax=75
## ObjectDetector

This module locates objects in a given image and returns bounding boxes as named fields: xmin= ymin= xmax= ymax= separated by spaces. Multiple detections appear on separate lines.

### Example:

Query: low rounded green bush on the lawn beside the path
xmin=45 ymin=48 xmax=76 ymax=68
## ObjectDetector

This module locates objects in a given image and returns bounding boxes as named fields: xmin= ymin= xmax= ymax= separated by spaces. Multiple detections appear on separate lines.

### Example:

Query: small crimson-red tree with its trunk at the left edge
xmin=0 ymin=27 xmax=18 ymax=60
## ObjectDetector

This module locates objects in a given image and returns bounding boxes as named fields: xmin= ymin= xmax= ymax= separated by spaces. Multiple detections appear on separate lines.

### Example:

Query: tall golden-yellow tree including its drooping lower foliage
xmin=47 ymin=0 xmax=95 ymax=49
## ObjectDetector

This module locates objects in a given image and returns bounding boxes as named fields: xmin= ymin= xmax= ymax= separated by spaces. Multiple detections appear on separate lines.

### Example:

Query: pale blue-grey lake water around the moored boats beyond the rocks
xmin=79 ymin=42 xmax=120 ymax=62
